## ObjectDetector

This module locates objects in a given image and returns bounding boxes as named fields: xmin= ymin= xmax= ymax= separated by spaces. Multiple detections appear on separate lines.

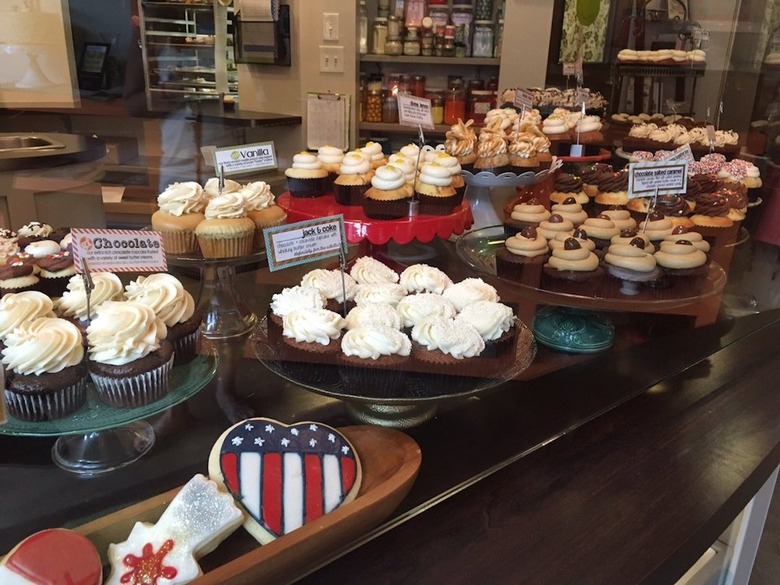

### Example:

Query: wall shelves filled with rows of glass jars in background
xmin=358 ymin=0 xmax=504 ymax=141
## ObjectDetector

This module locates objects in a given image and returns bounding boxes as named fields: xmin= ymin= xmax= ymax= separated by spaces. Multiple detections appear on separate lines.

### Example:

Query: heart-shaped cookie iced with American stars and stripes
xmin=209 ymin=418 xmax=361 ymax=544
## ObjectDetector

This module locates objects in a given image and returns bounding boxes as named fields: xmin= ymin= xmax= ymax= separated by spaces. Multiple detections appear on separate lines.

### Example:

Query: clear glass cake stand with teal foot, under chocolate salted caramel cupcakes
xmin=455 ymin=225 xmax=726 ymax=353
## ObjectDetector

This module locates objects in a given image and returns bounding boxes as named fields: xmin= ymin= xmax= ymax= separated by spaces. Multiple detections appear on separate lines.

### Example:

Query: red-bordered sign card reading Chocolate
xmin=70 ymin=228 xmax=168 ymax=273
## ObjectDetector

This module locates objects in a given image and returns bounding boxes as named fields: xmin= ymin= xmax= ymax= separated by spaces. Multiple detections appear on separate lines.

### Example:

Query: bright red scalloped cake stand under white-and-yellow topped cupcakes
xmin=276 ymin=192 xmax=474 ymax=245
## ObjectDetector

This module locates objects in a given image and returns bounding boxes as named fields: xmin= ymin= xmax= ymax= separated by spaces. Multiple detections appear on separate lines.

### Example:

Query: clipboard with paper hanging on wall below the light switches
xmin=306 ymin=92 xmax=350 ymax=150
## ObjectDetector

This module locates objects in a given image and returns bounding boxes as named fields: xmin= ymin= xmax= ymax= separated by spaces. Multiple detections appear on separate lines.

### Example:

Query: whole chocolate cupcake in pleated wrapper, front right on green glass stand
xmin=87 ymin=301 xmax=173 ymax=408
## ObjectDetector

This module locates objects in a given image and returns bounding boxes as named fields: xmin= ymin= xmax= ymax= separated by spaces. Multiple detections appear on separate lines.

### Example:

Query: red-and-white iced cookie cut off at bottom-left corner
xmin=0 ymin=528 xmax=103 ymax=585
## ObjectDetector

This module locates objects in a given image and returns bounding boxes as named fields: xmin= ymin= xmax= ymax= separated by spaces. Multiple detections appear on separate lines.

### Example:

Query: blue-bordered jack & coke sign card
xmin=263 ymin=215 xmax=347 ymax=271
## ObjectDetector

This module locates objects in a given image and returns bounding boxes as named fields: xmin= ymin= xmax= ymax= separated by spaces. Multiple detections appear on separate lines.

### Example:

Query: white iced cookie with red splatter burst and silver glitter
xmin=106 ymin=474 xmax=244 ymax=585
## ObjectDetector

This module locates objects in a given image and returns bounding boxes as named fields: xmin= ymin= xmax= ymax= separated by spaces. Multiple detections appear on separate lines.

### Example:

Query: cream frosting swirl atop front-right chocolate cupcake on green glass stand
xmin=87 ymin=301 xmax=168 ymax=366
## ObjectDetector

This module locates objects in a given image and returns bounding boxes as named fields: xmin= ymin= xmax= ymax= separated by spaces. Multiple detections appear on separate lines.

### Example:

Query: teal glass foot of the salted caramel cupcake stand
xmin=533 ymin=306 xmax=615 ymax=353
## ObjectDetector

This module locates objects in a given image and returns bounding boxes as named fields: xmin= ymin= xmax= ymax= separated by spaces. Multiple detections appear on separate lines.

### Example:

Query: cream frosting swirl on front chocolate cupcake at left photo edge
xmin=3 ymin=317 xmax=84 ymax=375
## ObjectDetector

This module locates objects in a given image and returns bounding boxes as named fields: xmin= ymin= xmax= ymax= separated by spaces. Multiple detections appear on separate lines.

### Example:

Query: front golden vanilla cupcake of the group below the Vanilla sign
xmin=195 ymin=192 xmax=256 ymax=258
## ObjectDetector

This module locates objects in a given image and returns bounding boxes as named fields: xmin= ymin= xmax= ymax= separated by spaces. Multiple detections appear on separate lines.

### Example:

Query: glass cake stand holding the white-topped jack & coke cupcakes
xmin=251 ymin=318 xmax=536 ymax=428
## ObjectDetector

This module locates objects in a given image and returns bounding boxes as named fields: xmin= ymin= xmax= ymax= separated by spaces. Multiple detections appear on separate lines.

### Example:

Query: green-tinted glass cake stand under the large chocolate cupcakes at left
xmin=0 ymin=355 xmax=218 ymax=477
